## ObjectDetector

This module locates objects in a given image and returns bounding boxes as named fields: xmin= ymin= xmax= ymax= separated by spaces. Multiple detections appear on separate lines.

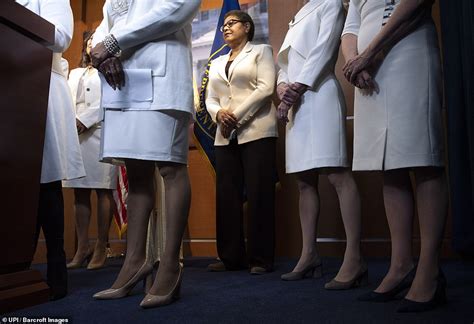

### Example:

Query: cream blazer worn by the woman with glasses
xmin=206 ymin=42 xmax=278 ymax=145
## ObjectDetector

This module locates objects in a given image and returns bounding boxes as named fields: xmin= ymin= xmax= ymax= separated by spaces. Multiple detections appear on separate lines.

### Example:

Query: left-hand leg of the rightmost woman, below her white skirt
xmin=375 ymin=169 xmax=414 ymax=293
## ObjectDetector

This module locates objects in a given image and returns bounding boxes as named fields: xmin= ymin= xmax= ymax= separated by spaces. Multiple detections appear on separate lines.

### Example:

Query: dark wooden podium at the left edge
xmin=0 ymin=0 xmax=54 ymax=314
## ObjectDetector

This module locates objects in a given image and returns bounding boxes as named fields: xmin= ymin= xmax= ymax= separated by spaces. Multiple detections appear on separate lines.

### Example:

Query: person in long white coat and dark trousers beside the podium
xmin=17 ymin=0 xmax=85 ymax=299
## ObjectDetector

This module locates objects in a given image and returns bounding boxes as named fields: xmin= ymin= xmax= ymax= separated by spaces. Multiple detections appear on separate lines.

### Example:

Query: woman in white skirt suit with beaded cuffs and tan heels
xmin=91 ymin=0 xmax=201 ymax=308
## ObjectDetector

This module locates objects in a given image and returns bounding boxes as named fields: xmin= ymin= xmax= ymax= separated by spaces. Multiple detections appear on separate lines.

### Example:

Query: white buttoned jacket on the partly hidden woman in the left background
xmin=68 ymin=68 xmax=102 ymax=128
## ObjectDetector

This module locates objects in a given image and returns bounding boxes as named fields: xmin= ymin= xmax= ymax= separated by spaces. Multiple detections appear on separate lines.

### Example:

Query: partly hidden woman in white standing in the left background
xmin=63 ymin=31 xmax=117 ymax=270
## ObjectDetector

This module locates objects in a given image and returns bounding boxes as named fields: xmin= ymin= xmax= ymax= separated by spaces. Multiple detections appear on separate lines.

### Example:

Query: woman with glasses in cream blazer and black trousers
xmin=206 ymin=10 xmax=277 ymax=274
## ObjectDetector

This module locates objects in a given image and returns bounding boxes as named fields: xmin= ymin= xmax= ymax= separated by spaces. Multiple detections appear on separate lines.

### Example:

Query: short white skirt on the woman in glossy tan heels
xmin=100 ymin=109 xmax=192 ymax=164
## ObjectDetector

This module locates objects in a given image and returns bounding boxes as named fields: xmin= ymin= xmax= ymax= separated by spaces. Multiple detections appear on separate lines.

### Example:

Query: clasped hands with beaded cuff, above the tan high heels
xmin=91 ymin=42 xmax=125 ymax=90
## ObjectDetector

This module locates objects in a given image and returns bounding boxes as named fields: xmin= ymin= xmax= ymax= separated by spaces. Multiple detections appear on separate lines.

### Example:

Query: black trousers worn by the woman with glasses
xmin=215 ymin=137 xmax=276 ymax=270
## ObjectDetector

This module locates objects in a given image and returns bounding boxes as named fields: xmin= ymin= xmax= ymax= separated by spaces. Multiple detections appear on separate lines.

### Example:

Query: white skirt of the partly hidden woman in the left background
xmin=63 ymin=127 xmax=117 ymax=189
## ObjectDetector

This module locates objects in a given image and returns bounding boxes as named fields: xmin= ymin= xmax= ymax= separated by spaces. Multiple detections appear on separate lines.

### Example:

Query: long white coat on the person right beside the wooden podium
xmin=17 ymin=0 xmax=85 ymax=183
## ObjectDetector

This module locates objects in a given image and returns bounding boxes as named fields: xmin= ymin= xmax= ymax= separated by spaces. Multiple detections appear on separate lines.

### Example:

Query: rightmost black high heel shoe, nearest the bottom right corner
xmin=397 ymin=269 xmax=447 ymax=313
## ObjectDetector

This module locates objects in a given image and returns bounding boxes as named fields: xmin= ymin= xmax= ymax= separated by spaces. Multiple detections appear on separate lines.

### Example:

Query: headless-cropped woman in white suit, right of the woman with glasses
xmin=278 ymin=0 xmax=367 ymax=289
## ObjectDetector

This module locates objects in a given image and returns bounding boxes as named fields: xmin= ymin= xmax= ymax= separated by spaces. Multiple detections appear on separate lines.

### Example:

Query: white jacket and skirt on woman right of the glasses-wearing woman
xmin=278 ymin=0 xmax=347 ymax=173
